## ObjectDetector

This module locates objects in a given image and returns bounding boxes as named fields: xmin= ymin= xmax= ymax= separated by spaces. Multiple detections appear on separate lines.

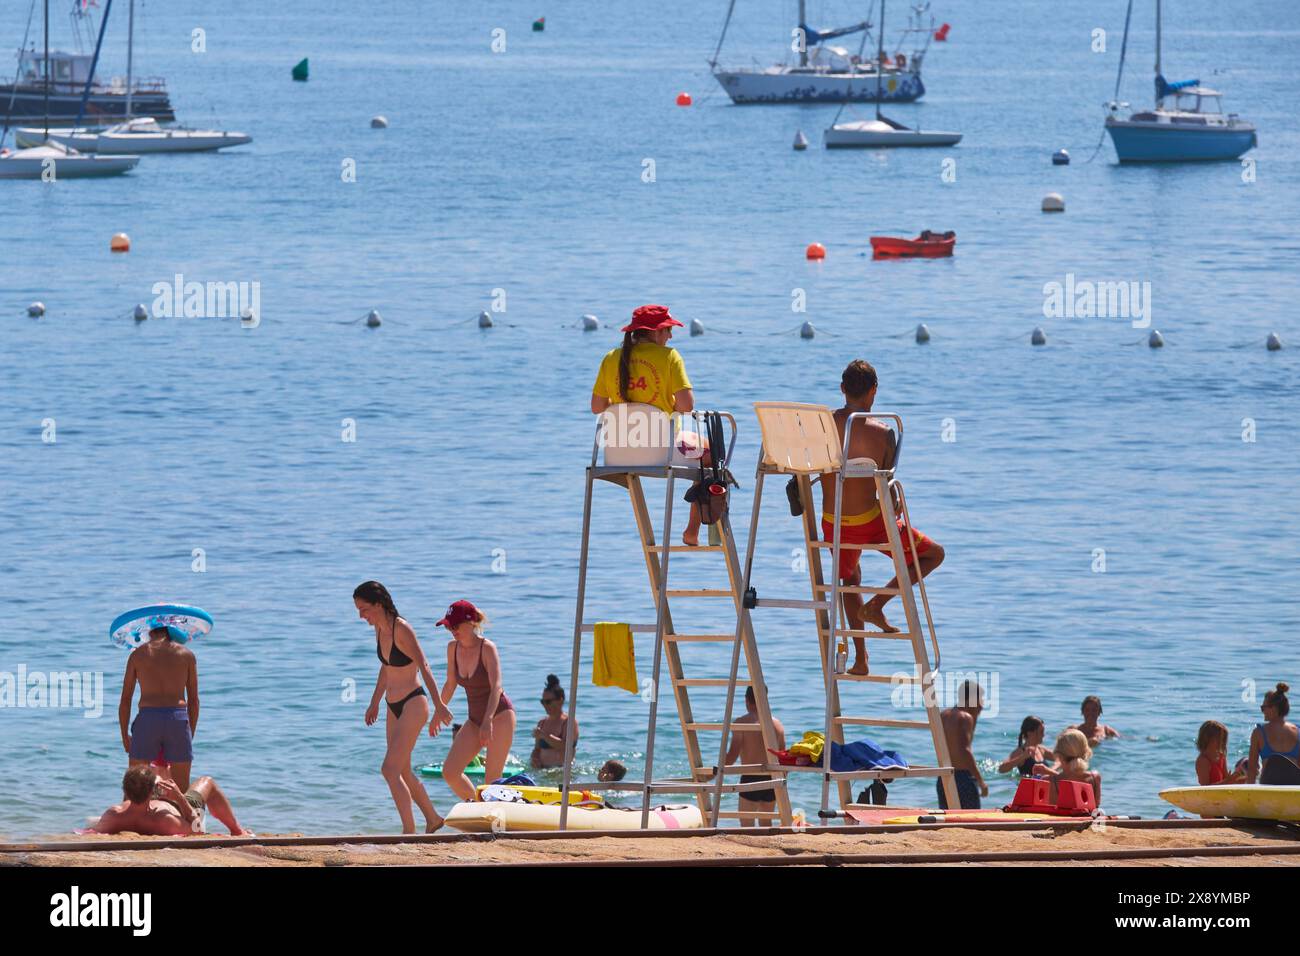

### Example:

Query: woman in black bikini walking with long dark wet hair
xmin=352 ymin=581 xmax=451 ymax=834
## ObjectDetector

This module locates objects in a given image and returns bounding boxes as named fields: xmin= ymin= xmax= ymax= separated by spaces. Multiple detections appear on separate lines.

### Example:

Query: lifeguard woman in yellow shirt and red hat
xmin=592 ymin=306 xmax=707 ymax=545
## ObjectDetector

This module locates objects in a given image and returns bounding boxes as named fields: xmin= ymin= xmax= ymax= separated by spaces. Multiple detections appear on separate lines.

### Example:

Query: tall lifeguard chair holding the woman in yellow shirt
xmin=559 ymin=403 xmax=792 ymax=830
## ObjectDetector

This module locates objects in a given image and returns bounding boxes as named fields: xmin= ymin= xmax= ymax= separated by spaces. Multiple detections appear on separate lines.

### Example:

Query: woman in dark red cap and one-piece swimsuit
xmin=430 ymin=601 xmax=515 ymax=800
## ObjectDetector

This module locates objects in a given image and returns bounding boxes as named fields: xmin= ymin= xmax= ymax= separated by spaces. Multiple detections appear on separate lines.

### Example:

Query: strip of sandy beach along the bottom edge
xmin=0 ymin=821 xmax=1300 ymax=868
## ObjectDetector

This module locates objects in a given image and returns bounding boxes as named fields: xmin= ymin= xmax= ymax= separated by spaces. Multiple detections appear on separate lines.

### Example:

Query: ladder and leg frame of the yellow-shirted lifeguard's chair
xmin=560 ymin=416 xmax=792 ymax=829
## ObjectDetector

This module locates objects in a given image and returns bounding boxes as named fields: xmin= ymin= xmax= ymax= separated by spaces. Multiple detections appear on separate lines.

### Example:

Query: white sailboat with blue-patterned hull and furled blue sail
xmin=710 ymin=0 xmax=933 ymax=104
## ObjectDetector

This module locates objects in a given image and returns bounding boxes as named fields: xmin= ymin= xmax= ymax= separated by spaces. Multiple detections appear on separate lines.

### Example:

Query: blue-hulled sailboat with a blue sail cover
xmin=1106 ymin=0 xmax=1258 ymax=163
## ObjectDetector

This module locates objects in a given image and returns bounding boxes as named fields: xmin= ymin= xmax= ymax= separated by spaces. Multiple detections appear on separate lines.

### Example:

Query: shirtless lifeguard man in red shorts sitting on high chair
xmin=822 ymin=359 xmax=944 ymax=674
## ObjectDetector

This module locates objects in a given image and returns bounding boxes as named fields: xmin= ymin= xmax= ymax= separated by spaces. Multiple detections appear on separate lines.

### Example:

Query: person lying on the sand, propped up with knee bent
xmin=91 ymin=765 xmax=252 ymax=836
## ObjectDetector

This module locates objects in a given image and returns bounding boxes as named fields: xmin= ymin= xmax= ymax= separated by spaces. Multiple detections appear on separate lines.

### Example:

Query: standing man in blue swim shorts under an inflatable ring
xmin=117 ymin=627 xmax=199 ymax=792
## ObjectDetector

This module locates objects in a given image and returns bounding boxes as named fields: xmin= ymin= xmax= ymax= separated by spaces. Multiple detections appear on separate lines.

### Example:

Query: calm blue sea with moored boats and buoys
xmin=0 ymin=0 xmax=1300 ymax=836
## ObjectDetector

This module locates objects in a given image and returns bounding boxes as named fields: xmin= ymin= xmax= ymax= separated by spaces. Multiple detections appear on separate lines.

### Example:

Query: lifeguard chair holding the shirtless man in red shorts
xmin=737 ymin=402 xmax=961 ymax=819
